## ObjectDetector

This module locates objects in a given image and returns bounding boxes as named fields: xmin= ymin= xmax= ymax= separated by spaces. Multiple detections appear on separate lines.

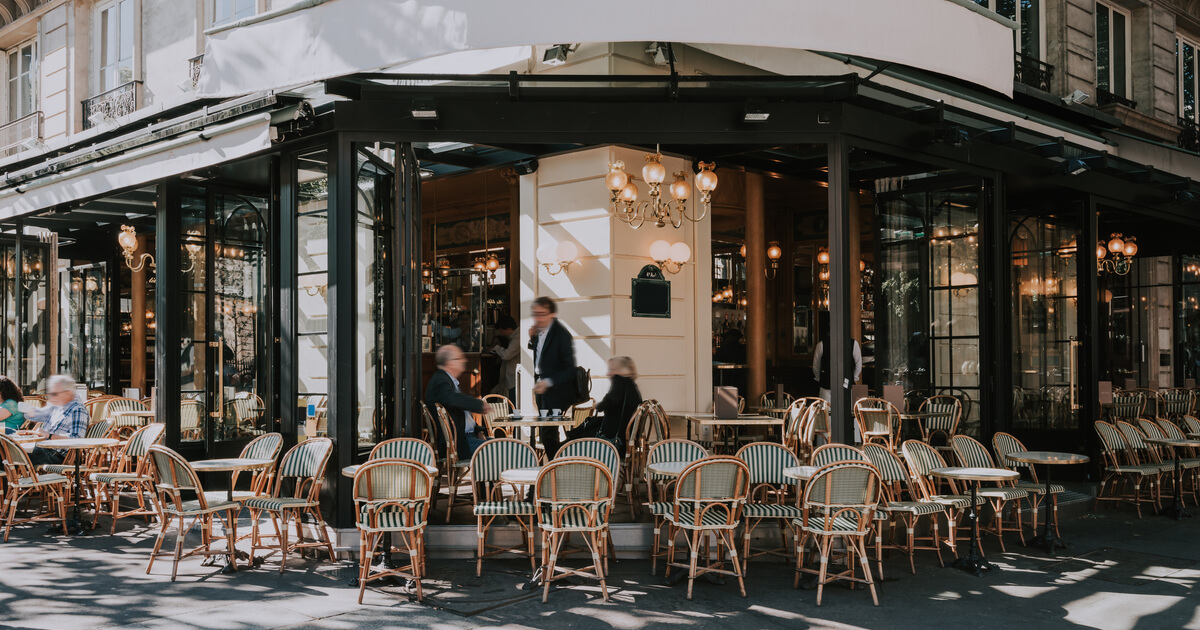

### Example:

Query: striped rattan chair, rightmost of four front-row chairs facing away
xmin=792 ymin=462 xmax=883 ymax=606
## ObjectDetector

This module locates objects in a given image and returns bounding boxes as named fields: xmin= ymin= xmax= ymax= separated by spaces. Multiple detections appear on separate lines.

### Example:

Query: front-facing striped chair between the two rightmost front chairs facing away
xmin=737 ymin=442 xmax=803 ymax=575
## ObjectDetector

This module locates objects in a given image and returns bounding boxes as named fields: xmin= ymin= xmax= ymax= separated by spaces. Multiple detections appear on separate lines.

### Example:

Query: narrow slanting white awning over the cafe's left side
xmin=0 ymin=113 xmax=271 ymax=220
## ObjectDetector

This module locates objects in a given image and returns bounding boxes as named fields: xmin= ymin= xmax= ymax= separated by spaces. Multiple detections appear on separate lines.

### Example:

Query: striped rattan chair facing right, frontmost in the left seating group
xmin=146 ymin=444 xmax=241 ymax=582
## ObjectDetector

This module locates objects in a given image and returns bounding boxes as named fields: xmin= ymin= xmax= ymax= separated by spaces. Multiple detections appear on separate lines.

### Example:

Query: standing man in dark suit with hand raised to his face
xmin=529 ymin=296 xmax=576 ymax=458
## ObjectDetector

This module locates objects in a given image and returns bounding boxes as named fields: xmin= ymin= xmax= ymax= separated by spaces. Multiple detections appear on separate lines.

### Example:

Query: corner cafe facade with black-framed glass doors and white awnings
xmin=7 ymin=0 xmax=1200 ymax=530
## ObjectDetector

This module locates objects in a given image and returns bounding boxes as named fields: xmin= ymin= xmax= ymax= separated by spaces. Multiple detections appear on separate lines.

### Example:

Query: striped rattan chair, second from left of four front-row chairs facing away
xmin=534 ymin=457 xmax=616 ymax=604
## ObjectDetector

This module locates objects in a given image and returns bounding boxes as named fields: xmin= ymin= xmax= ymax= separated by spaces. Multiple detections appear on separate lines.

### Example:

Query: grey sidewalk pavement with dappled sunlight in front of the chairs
xmin=0 ymin=508 xmax=1200 ymax=630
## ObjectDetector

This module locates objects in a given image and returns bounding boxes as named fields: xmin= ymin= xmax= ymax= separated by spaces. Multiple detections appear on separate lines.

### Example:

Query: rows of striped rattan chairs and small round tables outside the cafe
xmin=11 ymin=388 xmax=1200 ymax=606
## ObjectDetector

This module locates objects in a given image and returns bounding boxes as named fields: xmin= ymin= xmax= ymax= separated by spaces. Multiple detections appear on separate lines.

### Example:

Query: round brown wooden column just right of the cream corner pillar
xmin=743 ymin=173 xmax=770 ymax=404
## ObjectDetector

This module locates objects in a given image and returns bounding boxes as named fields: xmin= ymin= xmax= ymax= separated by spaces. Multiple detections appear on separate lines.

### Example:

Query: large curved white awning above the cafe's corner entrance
xmin=196 ymin=0 xmax=1014 ymax=97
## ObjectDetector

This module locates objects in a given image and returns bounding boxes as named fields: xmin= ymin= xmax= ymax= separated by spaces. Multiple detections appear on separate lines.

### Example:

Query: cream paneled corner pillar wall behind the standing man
xmin=520 ymin=146 xmax=712 ymax=410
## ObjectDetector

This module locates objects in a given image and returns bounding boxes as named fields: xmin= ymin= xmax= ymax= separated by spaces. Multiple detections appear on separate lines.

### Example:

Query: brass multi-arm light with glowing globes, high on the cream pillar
xmin=605 ymin=148 xmax=716 ymax=229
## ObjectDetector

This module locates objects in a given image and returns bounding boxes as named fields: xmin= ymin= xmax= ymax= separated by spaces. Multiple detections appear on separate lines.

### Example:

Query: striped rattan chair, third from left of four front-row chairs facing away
xmin=665 ymin=455 xmax=750 ymax=600
